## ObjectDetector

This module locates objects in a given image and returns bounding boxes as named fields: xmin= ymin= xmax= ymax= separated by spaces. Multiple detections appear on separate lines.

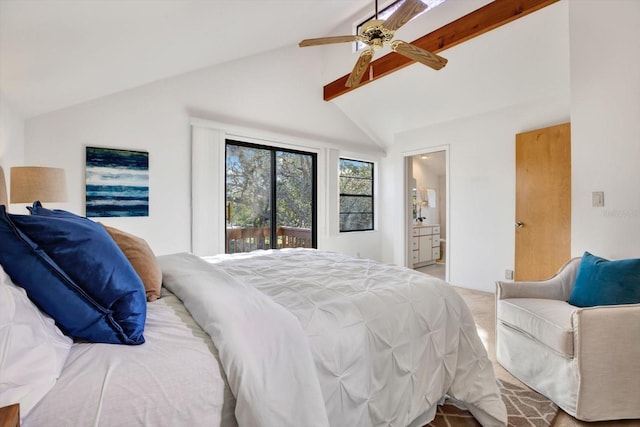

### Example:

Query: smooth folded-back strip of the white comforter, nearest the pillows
xmin=162 ymin=254 xmax=329 ymax=427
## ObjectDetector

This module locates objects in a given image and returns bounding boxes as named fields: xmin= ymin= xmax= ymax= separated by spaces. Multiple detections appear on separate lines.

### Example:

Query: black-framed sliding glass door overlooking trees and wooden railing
xmin=226 ymin=140 xmax=317 ymax=253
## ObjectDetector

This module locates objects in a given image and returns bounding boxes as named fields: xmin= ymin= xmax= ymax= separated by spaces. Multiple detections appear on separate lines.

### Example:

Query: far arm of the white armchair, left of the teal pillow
xmin=496 ymin=258 xmax=580 ymax=301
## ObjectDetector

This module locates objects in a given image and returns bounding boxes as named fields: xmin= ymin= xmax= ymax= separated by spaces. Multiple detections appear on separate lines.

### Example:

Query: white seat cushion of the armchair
xmin=497 ymin=298 xmax=576 ymax=357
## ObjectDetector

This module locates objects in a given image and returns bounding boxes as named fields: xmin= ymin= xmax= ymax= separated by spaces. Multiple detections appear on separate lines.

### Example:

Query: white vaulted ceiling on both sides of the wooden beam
xmin=0 ymin=0 xmax=569 ymax=148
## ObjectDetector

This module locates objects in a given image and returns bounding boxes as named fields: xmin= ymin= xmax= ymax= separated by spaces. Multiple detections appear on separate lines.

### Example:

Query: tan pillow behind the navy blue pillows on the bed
xmin=100 ymin=224 xmax=162 ymax=301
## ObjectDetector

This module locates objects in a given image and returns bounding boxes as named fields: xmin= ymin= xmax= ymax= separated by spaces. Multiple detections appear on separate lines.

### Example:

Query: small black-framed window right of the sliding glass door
xmin=340 ymin=159 xmax=373 ymax=232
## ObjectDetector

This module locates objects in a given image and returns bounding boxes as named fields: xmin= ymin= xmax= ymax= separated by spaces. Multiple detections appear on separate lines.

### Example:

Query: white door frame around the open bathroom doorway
xmin=402 ymin=144 xmax=452 ymax=282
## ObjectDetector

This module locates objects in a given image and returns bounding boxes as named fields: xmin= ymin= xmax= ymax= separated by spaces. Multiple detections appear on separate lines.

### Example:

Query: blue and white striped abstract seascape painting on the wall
xmin=85 ymin=147 xmax=149 ymax=221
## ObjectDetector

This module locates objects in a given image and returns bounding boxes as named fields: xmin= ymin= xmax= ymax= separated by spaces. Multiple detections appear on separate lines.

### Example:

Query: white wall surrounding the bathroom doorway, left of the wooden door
xmin=381 ymin=95 xmax=569 ymax=292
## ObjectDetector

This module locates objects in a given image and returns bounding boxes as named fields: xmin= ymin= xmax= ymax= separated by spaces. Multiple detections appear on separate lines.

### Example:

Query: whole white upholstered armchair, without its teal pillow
xmin=496 ymin=258 xmax=640 ymax=421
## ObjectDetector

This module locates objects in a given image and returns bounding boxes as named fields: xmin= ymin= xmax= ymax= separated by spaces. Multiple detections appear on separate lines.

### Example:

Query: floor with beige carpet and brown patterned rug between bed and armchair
xmin=429 ymin=286 xmax=640 ymax=427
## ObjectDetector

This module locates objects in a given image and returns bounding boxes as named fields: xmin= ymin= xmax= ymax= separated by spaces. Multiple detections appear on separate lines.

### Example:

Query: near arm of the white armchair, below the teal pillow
xmin=571 ymin=304 xmax=640 ymax=420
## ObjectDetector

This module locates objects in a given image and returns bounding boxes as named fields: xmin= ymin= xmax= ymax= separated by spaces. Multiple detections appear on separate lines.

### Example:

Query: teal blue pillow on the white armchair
xmin=568 ymin=252 xmax=640 ymax=307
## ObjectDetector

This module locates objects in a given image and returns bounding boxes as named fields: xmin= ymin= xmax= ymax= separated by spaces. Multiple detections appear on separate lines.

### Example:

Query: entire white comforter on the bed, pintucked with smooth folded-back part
xmin=161 ymin=249 xmax=507 ymax=427
